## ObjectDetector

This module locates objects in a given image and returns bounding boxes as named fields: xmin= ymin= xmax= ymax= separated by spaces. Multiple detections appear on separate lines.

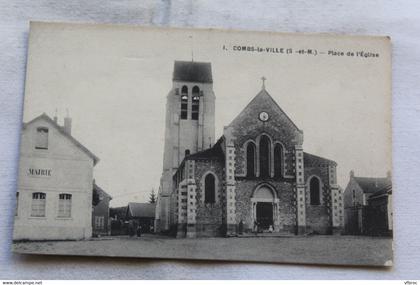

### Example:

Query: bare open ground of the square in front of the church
xmin=13 ymin=235 xmax=392 ymax=266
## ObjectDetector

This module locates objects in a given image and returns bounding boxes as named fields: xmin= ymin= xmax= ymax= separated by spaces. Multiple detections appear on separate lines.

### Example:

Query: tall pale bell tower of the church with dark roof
xmin=155 ymin=61 xmax=216 ymax=231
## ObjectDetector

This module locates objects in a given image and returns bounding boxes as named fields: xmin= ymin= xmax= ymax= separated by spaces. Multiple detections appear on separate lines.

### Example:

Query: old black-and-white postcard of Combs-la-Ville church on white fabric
xmin=12 ymin=22 xmax=393 ymax=267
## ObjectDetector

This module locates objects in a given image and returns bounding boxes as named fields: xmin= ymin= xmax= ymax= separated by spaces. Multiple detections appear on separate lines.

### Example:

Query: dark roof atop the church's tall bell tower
xmin=172 ymin=61 xmax=213 ymax=83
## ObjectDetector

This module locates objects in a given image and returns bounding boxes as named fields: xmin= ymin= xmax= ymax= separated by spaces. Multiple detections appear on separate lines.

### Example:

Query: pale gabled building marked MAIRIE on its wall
xmin=13 ymin=113 xmax=99 ymax=240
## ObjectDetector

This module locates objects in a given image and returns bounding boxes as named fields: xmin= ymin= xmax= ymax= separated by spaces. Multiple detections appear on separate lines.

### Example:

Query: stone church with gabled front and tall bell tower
xmin=155 ymin=61 xmax=343 ymax=238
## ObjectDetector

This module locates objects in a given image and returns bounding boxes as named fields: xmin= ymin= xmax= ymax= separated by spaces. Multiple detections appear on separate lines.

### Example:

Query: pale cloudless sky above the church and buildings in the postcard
xmin=23 ymin=23 xmax=392 ymax=206
